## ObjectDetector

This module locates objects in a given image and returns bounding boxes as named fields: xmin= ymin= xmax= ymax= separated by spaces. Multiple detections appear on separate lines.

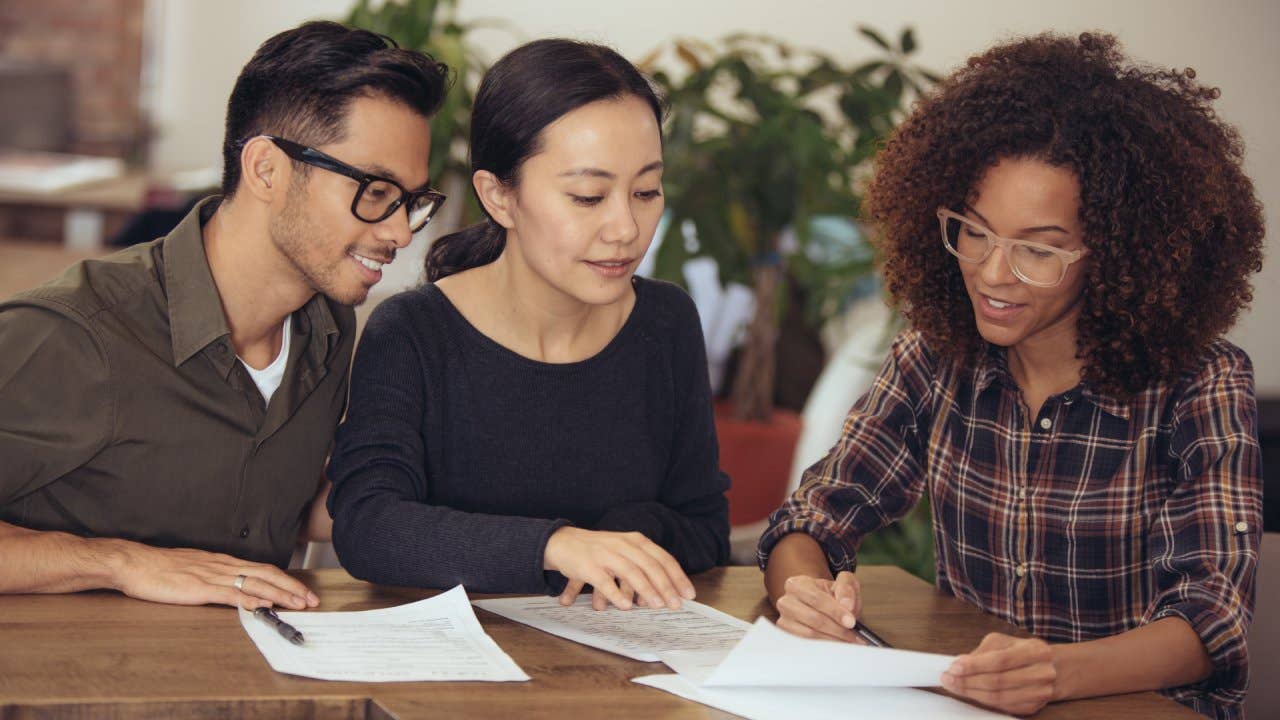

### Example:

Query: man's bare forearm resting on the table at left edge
xmin=0 ymin=523 xmax=125 ymax=593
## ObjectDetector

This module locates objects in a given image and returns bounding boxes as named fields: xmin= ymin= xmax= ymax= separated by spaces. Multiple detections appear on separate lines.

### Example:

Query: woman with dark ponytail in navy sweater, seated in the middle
xmin=329 ymin=40 xmax=728 ymax=609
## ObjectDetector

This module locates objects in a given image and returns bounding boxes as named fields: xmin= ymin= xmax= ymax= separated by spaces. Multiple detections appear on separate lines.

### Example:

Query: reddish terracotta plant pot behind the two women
xmin=716 ymin=401 xmax=800 ymax=525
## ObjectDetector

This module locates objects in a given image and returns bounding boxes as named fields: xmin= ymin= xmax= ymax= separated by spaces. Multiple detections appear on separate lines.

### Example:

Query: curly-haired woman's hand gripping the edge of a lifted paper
xmin=942 ymin=633 xmax=1057 ymax=715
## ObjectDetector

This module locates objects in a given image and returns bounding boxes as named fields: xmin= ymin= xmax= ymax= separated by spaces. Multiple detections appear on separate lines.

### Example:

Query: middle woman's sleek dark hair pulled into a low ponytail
xmin=426 ymin=38 xmax=663 ymax=282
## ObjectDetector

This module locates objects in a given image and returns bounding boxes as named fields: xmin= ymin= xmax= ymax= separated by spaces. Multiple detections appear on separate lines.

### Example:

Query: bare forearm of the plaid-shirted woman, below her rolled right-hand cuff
xmin=1053 ymin=618 xmax=1213 ymax=701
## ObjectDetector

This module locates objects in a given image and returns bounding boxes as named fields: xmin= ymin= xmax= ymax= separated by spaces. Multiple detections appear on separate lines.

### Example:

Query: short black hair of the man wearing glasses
xmin=223 ymin=22 xmax=449 ymax=197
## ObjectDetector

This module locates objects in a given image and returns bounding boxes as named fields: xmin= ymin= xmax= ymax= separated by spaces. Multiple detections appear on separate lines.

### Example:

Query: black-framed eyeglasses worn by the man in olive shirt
xmin=262 ymin=135 xmax=445 ymax=232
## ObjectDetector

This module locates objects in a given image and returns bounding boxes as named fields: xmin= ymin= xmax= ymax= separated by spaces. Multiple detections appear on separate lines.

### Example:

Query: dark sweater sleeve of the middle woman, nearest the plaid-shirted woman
xmin=596 ymin=283 xmax=730 ymax=573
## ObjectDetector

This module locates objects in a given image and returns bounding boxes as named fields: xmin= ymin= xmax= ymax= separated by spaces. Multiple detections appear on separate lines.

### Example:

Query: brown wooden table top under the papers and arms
xmin=0 ymin=566 xmax=1199 ymax=720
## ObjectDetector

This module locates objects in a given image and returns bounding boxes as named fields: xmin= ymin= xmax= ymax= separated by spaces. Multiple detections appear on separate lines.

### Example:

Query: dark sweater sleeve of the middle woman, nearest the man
xmin=328 ymin=299 xmax=568 ymax=593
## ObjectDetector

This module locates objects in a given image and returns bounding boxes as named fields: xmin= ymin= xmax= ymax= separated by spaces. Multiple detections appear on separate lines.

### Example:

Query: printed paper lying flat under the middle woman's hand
xmin=472 ymin=596 xmax=751 ymax=662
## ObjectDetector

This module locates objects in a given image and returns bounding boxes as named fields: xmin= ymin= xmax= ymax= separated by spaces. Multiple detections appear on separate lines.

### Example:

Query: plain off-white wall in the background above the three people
xmin=151 ymin=0 xmax=1280 ymax=395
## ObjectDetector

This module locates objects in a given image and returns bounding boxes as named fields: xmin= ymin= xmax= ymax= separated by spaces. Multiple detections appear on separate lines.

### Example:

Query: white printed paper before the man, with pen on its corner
xmin=239 ymin=585 xmax=529 ymax=683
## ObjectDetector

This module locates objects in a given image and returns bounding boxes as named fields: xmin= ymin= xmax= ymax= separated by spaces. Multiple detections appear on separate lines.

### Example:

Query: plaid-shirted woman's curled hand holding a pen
xmin=774 ymin=571 xmax=867 ymax=644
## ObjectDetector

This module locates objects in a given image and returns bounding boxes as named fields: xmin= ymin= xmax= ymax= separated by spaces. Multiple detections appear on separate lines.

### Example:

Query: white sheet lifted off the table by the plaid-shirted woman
xmin=703 ymin=618 xmax=955 ymax=688
